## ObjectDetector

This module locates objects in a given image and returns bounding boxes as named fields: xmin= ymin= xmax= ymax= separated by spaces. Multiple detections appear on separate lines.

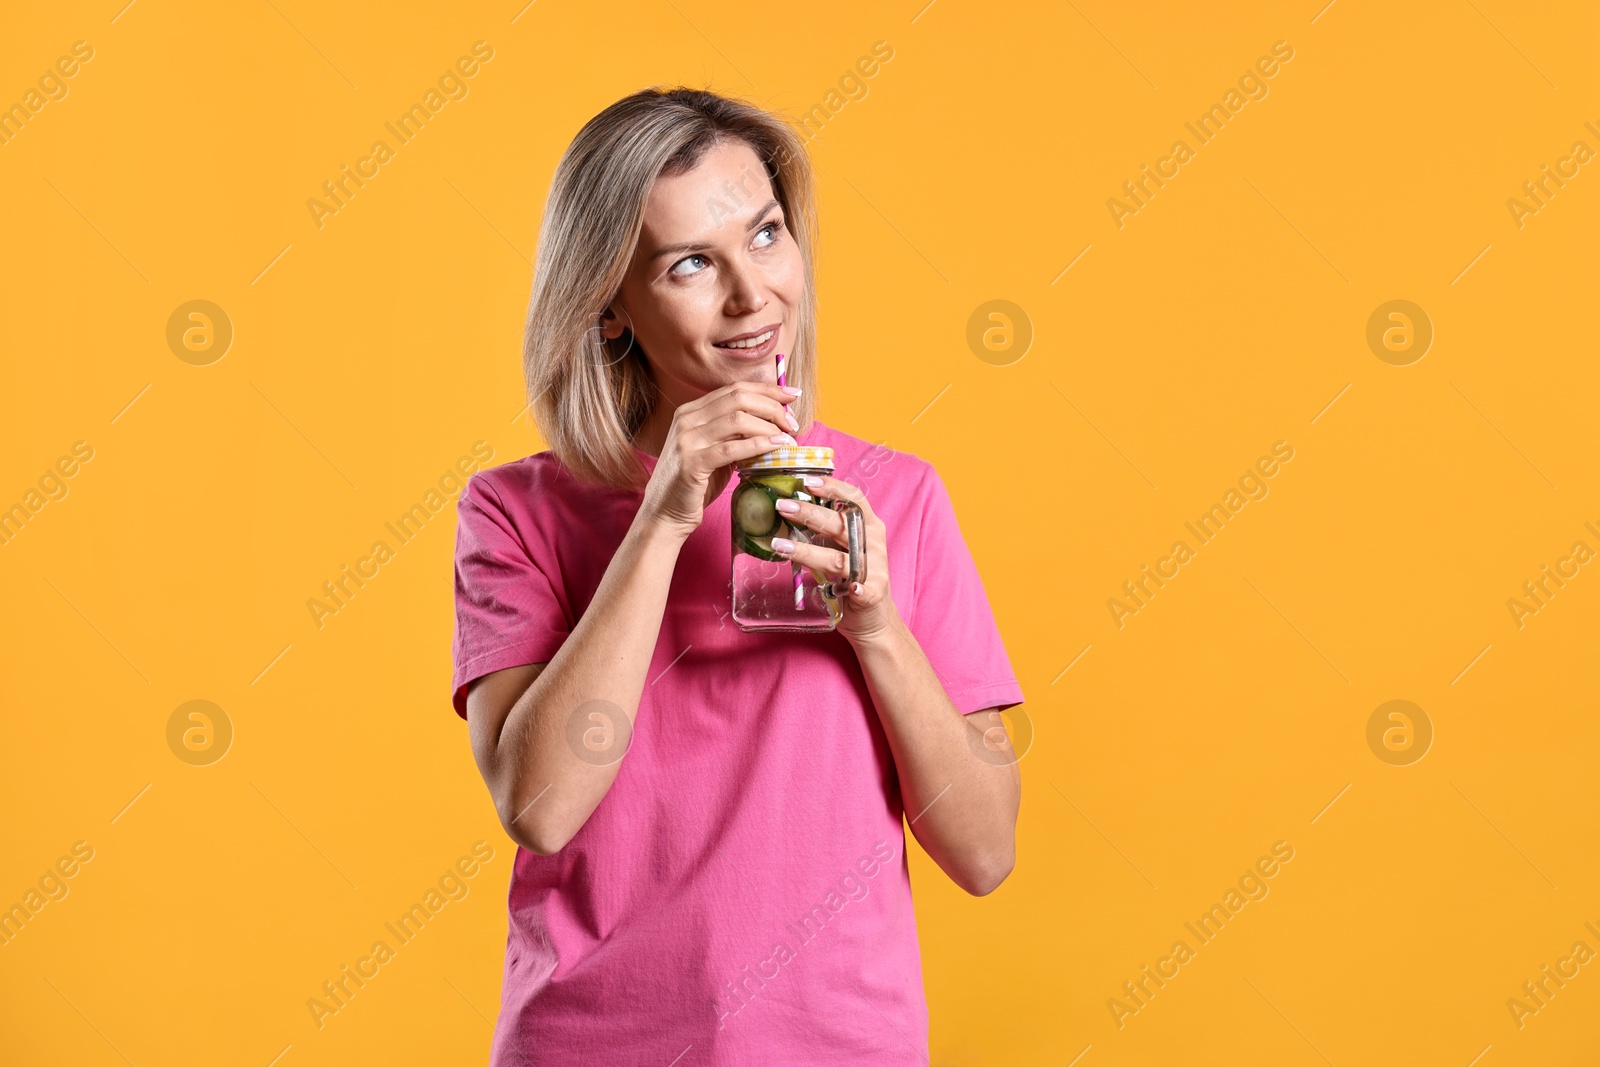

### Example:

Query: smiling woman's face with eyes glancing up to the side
xmin=602 ymin=141 xmax=805 ymax=406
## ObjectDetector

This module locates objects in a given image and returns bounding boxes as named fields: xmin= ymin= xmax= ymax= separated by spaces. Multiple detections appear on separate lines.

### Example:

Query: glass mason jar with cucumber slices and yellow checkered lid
xmin=730 ymin=445 xmax=867 ymax=633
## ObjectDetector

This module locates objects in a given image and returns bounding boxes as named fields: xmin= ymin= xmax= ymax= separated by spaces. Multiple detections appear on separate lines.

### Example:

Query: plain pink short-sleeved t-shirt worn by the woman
xmin=454 ymin=422 xmax=1022 ymax=1067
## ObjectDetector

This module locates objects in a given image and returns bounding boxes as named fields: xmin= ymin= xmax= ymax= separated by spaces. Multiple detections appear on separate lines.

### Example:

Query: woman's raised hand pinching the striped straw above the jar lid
xmin=640 ymin=382 xmax=798 ymax=537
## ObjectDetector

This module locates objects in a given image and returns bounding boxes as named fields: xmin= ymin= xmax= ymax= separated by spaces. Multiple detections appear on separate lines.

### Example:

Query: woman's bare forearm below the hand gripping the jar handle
xmin=856 ymin=621 xmax=1022 ymax=896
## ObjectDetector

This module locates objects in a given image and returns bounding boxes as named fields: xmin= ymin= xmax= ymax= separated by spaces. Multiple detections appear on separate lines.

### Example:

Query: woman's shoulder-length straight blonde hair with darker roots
xmin=523 ymin=88 xmax=816 ymax=490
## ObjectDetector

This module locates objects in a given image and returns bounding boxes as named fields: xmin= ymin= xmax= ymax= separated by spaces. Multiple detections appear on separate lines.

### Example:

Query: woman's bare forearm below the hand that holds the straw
xmin=493 ymin=517 xmax=683 ymax=856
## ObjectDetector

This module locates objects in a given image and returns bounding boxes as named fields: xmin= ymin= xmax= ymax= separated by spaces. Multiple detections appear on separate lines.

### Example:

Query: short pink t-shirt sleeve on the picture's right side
xmin=910 ymin=466 xmax=1022 ymax=715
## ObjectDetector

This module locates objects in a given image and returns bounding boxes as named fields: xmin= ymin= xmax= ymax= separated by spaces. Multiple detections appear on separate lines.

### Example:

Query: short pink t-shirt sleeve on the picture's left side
xmin=451 ymin=474 xmax=571 ymax=718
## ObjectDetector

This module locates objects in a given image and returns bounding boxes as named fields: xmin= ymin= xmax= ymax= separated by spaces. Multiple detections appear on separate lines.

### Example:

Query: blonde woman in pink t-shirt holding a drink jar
xmin=454 ymin=90 xmax=1022 ymax=1067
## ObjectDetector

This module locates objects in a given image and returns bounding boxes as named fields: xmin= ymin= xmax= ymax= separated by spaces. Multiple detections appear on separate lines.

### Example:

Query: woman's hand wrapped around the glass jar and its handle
xmin=773 ymin=477 xmax=899 ymax=645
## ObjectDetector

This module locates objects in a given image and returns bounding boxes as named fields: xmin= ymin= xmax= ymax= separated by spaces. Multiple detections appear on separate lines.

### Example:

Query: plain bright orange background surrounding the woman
xmin=0 ymin=0 xmax=1600 ymax=1067
